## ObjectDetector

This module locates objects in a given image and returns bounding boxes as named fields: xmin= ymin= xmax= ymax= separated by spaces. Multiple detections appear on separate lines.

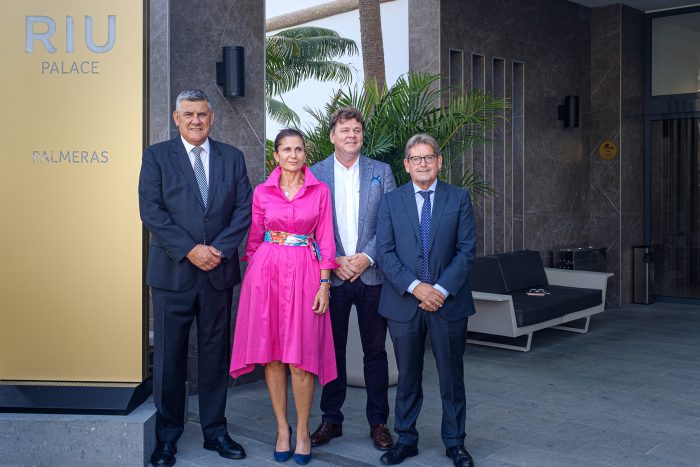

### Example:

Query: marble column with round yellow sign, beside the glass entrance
xmin=586 ymin=5 xmax=644 ymax=306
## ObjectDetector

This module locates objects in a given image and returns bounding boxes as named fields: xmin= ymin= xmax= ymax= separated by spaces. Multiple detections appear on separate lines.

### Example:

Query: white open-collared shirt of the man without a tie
xmin=333 ymin=157 xmax=360 ymax=256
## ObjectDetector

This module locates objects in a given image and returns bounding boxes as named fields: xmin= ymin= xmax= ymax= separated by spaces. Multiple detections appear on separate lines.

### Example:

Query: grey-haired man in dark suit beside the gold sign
xmin=139 ymin=90 xmax=252 ymax=465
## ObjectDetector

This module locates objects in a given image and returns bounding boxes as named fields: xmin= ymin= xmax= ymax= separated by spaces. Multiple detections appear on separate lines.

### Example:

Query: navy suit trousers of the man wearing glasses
xmin=388 ymin=309 xmax=468 ymax=448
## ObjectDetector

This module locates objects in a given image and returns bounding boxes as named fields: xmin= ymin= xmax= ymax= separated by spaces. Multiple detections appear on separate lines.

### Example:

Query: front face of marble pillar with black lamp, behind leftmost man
xmin=169 ymin=0 xmax=265 ymax=185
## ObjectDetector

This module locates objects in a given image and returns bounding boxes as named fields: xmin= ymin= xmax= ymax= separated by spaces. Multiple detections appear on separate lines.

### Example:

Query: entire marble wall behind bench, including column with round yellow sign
xmin=409 ymin=0 xmax=644 ymax=305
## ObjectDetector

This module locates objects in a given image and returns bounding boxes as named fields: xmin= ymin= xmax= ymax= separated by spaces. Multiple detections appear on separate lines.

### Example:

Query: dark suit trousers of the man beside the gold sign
xmin=151 ymin=271 xmax=232 ymax=442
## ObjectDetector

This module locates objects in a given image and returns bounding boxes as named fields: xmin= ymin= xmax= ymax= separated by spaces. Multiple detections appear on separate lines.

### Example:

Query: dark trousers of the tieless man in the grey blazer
xmin=321 ymin=279 xmax=389 ymax=425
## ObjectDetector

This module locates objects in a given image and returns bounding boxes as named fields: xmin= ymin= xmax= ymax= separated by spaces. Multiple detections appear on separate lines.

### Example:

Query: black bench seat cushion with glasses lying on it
xmin=511 ymin=284 xmax=603 ymax=327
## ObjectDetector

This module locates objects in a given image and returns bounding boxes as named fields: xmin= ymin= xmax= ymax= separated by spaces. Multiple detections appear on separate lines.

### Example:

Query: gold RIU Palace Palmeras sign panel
xmin=0 ymin=0 xmax=144 ymax=382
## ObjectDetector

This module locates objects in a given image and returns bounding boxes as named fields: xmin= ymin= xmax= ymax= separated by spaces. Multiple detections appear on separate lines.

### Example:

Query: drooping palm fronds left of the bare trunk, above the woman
xmin=265 ymin=26 xmax=358 ymax=125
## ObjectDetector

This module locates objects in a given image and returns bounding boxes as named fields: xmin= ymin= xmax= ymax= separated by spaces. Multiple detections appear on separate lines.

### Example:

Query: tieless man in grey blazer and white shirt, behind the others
xmin=311 ymin=108 xmax=396 ymax=450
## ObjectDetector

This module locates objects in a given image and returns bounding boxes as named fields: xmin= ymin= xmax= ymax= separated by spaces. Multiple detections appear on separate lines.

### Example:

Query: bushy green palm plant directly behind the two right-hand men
xmin=304 ymin=72 xmax=509 ymax=197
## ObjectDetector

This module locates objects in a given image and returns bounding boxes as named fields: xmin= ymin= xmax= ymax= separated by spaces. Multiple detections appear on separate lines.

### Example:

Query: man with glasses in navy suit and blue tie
xmin=377 ymin=135 xmax=476 ymax=467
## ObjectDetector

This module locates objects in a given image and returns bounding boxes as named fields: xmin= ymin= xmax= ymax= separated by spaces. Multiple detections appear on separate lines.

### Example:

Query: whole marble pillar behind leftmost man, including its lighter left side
xmin=149 ymin=0 xmax=265 ymax=392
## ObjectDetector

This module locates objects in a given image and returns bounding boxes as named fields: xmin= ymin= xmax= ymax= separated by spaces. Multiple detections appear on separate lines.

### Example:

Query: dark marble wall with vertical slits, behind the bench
xmin=424 ymin=0 xmax=590 ymax=258
